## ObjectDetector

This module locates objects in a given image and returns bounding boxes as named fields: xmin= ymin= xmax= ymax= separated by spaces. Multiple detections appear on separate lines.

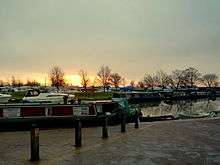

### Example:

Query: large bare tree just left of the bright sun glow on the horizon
xmin=49 ymin=66 xmax=65 ymax=89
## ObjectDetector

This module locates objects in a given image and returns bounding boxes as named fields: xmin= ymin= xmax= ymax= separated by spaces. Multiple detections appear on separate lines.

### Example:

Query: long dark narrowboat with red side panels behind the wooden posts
xmin=0 ymin=102 xmax=120 ymax=131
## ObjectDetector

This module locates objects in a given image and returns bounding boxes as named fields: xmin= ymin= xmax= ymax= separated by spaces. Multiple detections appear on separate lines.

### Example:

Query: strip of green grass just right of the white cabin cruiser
xmin=75 ymin=92 xmax=112 ymax=100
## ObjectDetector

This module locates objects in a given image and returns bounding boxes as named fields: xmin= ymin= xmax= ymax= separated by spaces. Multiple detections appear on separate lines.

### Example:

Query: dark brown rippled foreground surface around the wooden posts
xmin=0 ymin=118 xmax=220 ymax=165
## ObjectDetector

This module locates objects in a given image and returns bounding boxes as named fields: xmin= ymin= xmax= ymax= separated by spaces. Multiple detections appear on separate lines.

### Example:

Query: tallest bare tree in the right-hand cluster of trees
xmin=183 ymin=67 xmax=201 ymax=88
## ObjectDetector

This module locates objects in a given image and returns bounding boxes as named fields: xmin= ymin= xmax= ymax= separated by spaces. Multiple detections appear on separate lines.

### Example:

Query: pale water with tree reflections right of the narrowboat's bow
xmin=139 ymin=98 xmax=220 ymax=117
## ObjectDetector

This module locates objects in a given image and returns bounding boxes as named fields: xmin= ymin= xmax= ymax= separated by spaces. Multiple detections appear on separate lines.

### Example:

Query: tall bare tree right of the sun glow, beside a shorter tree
xmin=97 ymin=66 xmax=111 ymax=91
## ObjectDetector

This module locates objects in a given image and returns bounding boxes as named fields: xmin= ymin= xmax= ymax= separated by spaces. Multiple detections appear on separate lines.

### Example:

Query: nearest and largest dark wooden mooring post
xmin=31 ymin=124 xmax=40 ymax=161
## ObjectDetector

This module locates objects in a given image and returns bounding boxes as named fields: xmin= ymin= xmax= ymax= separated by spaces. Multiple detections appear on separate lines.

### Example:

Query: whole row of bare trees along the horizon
xmin=0 ymin=66 xmax=218 ymax=91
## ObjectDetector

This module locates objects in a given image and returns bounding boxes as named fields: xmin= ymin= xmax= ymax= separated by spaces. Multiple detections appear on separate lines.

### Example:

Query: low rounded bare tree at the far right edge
xmin=200 ymin=74 xmax=218 ymax=88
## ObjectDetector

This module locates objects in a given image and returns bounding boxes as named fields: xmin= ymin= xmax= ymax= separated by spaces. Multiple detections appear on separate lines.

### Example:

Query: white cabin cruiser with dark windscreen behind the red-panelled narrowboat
xmin=23 ymin=90 xmax=75 ymax=104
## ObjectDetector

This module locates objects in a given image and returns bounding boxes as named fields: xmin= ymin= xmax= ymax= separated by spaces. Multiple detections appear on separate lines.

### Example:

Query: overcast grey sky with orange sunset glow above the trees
xmin=0 ymin=0 xmax=220 ymax=85
